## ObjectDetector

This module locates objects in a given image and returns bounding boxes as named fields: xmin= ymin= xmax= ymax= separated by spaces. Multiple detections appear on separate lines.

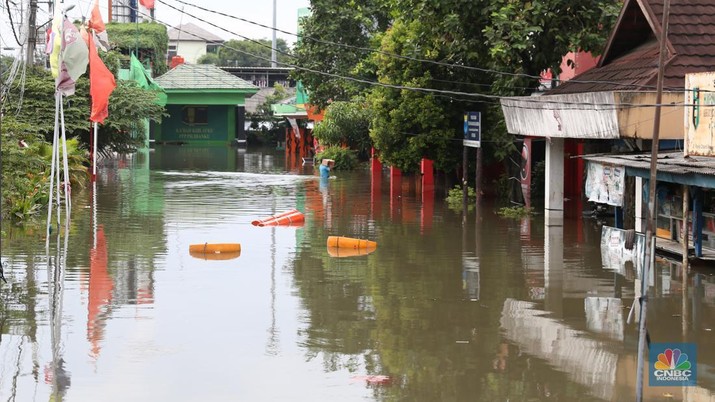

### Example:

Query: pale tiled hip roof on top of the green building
xmin=154 ymin=64 xmax=259 ymax=93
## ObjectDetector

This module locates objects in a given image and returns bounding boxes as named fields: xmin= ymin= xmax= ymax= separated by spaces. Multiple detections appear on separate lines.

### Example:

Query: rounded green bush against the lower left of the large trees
xmin=313 ymin=101 xmax=372 ymax=160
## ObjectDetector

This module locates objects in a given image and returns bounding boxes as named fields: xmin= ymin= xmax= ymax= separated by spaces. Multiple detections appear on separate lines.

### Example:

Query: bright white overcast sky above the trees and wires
xmin=0 ymin=0 xmax=310 ymax=54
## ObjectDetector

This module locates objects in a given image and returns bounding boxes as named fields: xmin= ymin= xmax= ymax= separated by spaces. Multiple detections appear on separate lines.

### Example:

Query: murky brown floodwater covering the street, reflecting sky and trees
xmin=0 ymin=147 xmax=715 ymax=402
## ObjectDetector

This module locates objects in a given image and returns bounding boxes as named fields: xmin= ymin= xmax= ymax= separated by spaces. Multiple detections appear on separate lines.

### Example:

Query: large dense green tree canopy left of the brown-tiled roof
xmin=294 ymin=0 xmax=621 ymax=171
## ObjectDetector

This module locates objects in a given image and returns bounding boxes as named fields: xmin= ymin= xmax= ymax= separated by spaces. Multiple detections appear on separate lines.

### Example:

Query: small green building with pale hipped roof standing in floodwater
xmin=152 ymin=64 xmax=259 ymax=145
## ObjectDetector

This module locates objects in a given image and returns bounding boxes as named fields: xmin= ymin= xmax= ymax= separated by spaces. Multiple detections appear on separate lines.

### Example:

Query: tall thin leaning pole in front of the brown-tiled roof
xmin=636 ymin=0 xmax=672 ymax=402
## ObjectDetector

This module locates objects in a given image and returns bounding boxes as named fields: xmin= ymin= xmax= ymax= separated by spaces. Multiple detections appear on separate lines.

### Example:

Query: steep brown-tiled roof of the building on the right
xmin=546 ymin=0 xmax=715 ymax=95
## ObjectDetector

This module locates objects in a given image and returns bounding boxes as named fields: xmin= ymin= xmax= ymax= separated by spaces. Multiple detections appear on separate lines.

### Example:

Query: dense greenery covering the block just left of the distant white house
xmin=107 ymin=22 xmax=169 ymax=76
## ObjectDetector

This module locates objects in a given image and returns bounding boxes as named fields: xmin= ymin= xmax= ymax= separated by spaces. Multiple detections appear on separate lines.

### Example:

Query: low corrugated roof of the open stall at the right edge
xmin=581 ymin=151 xmax=715 ymax=176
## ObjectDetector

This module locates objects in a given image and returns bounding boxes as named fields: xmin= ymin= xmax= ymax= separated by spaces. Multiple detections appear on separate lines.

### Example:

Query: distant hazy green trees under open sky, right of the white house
xmin=221 ymin=39 xmax=293 ymax=67
